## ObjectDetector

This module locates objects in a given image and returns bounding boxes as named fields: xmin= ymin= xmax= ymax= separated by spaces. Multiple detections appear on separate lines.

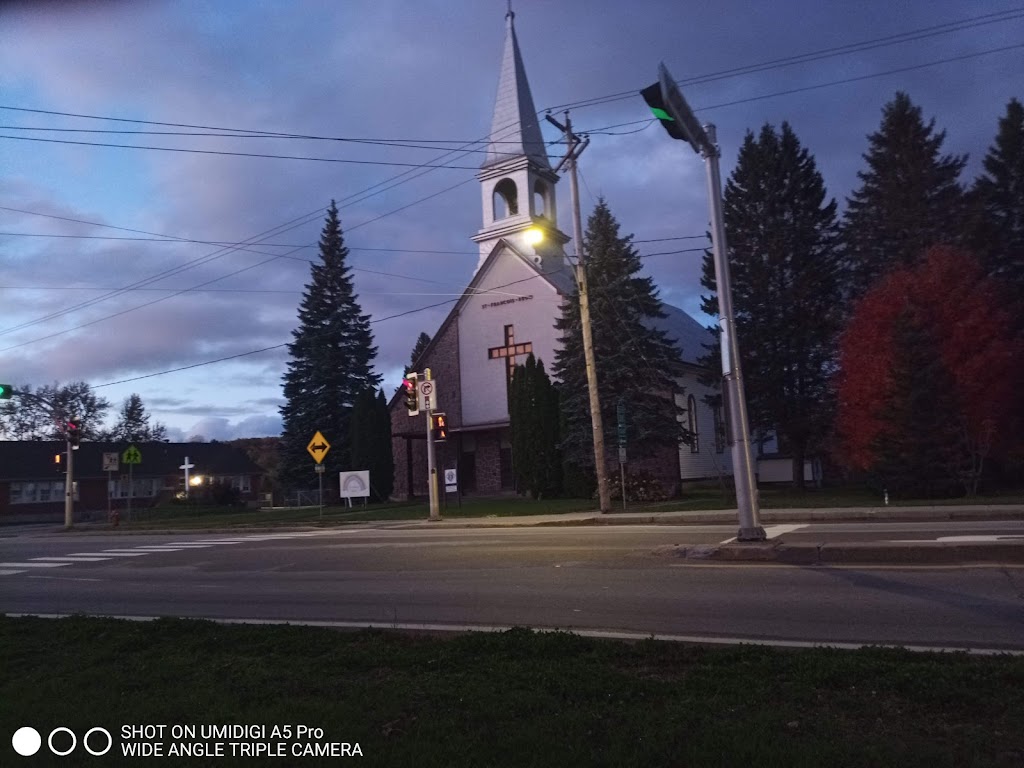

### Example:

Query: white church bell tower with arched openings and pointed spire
xmin=473 ymin=8 xmax=569 ymax=271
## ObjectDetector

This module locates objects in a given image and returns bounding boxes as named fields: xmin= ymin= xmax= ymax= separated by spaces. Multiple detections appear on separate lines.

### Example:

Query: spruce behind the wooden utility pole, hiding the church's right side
xmin=553 ymin=200 xmax=686 ymax=475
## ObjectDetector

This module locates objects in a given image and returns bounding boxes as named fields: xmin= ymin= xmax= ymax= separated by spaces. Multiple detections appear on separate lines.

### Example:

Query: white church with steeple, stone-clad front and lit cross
xmin=389 ymin=11 xmax=731 ymax=498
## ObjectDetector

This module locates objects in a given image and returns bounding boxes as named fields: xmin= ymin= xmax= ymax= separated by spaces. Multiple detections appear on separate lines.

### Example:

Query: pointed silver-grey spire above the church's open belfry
xmin=482 ymin=10 xmax=551 ymax=169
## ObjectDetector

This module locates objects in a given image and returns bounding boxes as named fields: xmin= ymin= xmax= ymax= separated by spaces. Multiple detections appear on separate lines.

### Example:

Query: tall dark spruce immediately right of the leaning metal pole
xmin=701 ymin=123 xmax=841 ymax=487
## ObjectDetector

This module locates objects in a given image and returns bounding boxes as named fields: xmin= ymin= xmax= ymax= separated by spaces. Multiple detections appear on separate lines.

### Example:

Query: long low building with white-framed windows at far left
xmin=0 ymin=440 xmax=263 ymax=523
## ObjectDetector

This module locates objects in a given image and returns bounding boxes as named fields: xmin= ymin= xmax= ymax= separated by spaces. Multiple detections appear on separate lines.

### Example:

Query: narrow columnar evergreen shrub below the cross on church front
xmin=509 ymin=352 xmax=561 ymax=499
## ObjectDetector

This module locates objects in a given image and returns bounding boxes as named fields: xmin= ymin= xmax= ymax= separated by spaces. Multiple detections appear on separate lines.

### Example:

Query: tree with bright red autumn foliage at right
xmin=837 ymin=247 xmax=1024 ymax=494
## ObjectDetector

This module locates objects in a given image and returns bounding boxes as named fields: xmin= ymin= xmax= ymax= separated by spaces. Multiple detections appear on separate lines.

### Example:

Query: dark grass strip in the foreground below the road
xmin=0 ymin=617 xmax=1024 ymax=768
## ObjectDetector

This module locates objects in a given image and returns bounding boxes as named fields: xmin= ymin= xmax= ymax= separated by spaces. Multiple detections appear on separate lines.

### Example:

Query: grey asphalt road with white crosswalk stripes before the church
xmin=0 ymin=521 xmax=1024 ymax=649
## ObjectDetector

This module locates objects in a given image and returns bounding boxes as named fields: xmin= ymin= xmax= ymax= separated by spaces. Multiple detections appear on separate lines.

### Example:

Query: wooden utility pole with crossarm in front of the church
xmin=545 ymin=112 xmax=610 ymax=514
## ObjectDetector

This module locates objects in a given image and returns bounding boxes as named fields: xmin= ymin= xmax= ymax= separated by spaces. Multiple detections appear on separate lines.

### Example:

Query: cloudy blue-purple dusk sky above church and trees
xmin=0 ymin=0 xmax=1024 ymax=439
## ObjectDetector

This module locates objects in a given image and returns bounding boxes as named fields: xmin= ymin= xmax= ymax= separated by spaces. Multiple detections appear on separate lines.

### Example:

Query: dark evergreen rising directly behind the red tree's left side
xmin=843 ymin=92 xmax=967 ymax=299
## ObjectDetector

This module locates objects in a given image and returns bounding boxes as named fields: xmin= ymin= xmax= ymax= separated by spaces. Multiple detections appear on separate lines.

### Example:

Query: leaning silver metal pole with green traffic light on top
xmin=640 ymin=63 xmax=766 ymax=542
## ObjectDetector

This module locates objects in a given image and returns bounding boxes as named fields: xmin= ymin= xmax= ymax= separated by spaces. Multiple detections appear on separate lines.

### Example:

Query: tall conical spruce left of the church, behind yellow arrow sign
xmin=281 ymin=201 xmax=380 ymax=488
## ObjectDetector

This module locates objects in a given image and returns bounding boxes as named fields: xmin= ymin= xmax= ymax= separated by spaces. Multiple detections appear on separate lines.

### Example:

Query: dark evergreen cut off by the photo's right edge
xmin=973 ymin=98 xmax=1024 ymax=297
